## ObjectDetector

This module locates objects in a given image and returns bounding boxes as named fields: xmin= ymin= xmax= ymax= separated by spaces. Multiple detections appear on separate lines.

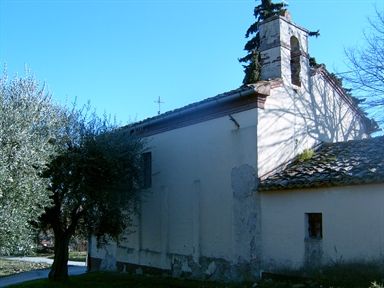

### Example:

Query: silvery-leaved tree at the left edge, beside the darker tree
xmin=0 ymin=67 xmax=66 ymax=254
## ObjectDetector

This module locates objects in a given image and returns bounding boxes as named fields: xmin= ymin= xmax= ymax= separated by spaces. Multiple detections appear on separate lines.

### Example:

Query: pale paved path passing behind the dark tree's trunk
xmin=0 ymin=257 xmax=87 ymax=287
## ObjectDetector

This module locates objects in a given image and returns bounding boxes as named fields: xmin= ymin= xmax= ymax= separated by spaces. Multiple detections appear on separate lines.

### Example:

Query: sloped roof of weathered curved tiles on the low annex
xmin=258 ymin=136 xmax=384 ymax=191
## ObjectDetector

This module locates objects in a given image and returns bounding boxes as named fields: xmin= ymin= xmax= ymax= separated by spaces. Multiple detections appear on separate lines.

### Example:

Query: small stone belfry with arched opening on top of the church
xmin=259 ymin=10 xmax=309 ymax=89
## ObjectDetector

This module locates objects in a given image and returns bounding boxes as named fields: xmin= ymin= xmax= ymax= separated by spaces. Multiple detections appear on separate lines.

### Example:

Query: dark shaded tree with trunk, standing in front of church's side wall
xmin=36 ymin=110 xmax=146 ymax=281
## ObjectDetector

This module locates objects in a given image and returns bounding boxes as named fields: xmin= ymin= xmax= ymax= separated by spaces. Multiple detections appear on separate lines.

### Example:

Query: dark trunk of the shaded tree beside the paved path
xmin=48 ymin=233 xmax=71 ymax=281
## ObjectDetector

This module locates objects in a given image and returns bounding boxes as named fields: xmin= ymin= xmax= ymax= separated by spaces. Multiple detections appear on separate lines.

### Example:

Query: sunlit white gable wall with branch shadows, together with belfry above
xmin=257 ymin=17 xmax=366 ymax=177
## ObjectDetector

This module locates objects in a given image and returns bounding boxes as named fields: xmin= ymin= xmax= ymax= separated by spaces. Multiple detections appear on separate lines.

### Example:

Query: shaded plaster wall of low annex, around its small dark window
xmin=260 ymin=184 xmax=384 ymax=271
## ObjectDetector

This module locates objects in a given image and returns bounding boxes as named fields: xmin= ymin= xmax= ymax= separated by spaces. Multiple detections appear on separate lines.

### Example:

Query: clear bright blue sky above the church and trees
xmin=0 ymin=0 xmax=384 ymax=124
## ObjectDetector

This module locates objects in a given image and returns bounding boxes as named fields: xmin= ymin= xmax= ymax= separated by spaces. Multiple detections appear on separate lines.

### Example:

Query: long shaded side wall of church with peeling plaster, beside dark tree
xmin=91 ymin=109 xmax=260 ymax=280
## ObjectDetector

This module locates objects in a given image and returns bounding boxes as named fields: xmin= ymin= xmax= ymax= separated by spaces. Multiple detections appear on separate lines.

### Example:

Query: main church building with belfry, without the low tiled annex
xmin=88 ymin=10 xmax=378 ymax=281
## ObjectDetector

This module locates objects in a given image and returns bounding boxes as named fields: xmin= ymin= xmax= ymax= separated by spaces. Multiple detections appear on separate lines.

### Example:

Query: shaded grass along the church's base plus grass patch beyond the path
xmin=0 ymin=259 xmax=384 ymax=288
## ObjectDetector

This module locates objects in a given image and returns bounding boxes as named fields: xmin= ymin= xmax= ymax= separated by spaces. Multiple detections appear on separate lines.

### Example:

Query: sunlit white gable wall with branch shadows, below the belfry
xmin=257 ymin=74 xmax=366 ymax=177
